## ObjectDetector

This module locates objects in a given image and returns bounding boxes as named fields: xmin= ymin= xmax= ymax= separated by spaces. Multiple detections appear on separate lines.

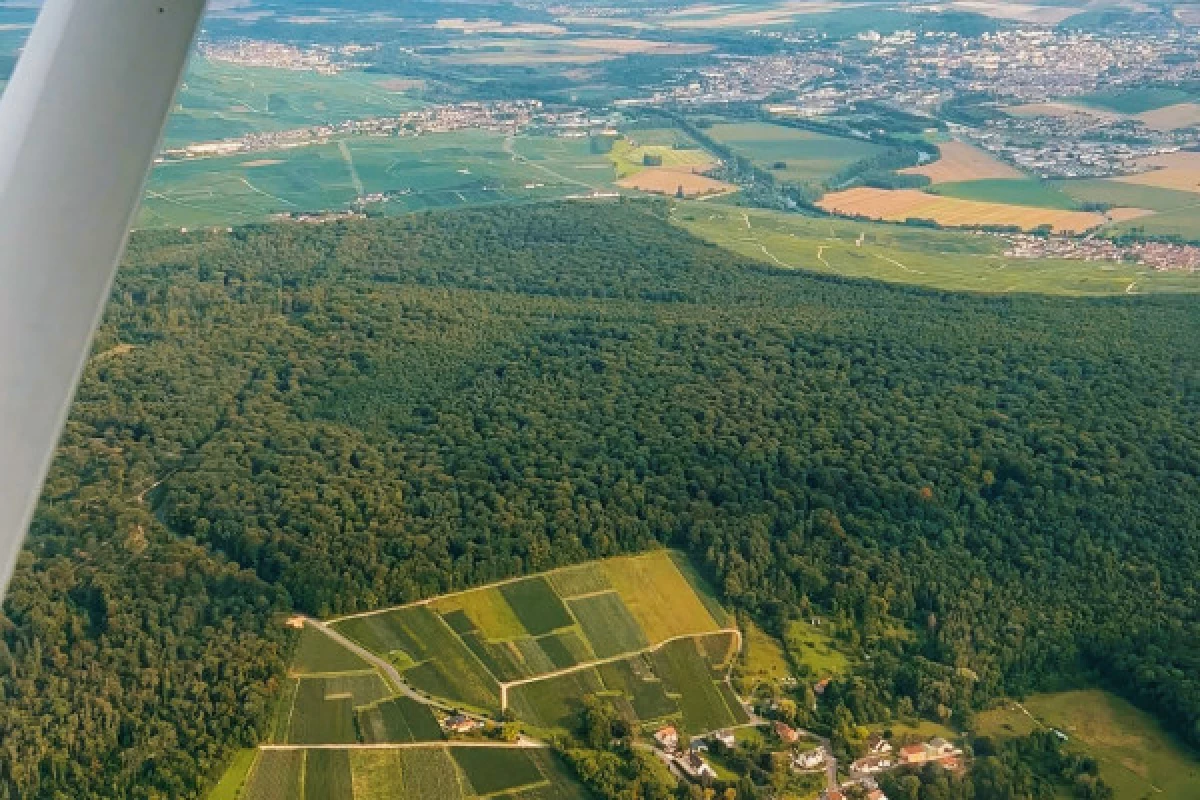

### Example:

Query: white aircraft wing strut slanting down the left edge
xmin=0 ymin=0 xmax=204 ymax=600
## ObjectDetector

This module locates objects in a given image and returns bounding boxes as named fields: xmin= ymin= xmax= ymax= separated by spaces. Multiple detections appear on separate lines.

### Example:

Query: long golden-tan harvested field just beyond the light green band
xmin=817 ymin=188 xmax=1108 ymax=233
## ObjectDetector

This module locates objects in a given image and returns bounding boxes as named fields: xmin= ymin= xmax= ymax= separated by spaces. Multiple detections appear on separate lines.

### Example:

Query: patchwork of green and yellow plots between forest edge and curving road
xmin=334 ymin=551 xmax=744 ymax=740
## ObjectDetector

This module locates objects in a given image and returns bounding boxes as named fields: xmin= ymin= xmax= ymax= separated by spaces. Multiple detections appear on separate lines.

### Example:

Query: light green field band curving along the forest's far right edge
xmin=672 ymin=203 xmax=1200 ymax=295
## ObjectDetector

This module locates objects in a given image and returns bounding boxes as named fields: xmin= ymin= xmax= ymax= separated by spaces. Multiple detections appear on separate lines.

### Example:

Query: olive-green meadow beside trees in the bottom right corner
xmin=976 ymin=690 xmax=1200 ymax=800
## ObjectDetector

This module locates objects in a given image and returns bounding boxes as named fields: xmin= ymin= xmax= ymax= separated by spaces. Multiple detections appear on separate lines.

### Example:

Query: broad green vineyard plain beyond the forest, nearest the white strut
xmin=137 ymin=131 xmax=613 ymax=228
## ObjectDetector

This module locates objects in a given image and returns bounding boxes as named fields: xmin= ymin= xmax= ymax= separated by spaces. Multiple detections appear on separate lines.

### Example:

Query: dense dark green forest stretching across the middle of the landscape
xmin=0 ymin=201 xmax=1200 ymax=799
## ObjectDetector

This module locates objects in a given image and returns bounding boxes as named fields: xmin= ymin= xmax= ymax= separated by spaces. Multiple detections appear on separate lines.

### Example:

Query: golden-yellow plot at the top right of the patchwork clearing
xmin=601 ymin=551 xmax=720 ymax=644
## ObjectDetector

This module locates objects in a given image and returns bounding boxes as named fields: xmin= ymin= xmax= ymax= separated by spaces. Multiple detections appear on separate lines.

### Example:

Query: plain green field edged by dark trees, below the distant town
xmin=706 ymin=122 xmax=882 ymax=184
